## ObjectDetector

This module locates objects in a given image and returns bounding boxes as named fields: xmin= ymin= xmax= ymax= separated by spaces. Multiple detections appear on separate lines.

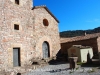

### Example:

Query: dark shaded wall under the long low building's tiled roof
xmin=61 ymin=38 xmax=98 ymax=54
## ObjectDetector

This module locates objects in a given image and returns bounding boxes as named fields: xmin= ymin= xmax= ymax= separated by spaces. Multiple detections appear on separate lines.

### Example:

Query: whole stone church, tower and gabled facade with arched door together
xmin=0 ymin=0 xmax=60 ymax=68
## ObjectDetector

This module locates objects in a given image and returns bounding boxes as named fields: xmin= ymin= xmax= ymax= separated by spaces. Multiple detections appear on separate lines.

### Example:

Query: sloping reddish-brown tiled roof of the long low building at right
xmin=60 ymin=33 xmax=100 ymax=43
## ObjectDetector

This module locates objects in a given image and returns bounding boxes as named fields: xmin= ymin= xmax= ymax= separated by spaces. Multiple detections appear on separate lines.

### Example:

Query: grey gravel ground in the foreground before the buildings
xmin=24 ymin=64 xmax=100 ymax=75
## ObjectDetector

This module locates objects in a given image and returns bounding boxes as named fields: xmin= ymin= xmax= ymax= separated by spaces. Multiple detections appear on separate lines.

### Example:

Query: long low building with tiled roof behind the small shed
xmin=60 ymin=33 xmax=100 ymax=58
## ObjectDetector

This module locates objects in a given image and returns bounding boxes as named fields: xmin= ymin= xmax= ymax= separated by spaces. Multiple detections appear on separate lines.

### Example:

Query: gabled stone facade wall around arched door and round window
xmin=33 ymin=7 xmax=60 ymax=57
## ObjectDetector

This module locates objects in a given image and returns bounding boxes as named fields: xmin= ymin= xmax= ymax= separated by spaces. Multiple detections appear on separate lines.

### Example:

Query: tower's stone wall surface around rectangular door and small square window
xmin=0 ymin=0 xmax=35 ymax=68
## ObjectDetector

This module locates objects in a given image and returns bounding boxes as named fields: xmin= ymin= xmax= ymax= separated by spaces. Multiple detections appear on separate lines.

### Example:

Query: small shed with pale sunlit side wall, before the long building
xmin=68 ymin=45 xmax=93 ymax=62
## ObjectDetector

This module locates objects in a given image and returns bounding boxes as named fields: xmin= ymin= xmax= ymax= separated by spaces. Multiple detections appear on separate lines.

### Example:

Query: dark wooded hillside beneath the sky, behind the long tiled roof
xmin=60 ymin=27 xmax=100 ymax=37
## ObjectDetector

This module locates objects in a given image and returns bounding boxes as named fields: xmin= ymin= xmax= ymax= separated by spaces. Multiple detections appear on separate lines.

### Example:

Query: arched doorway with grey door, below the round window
xmin=42 ymin=41 xmax=50 ymax=59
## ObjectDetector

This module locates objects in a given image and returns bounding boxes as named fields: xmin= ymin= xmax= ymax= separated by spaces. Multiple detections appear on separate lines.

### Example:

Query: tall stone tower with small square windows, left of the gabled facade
xmin=0 ymin=0 xmax=33 ymax=68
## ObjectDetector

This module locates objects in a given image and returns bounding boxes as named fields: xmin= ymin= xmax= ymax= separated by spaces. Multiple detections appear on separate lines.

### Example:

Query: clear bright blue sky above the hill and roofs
xmin=33 ymin=0 xmax=100 ymax=32
